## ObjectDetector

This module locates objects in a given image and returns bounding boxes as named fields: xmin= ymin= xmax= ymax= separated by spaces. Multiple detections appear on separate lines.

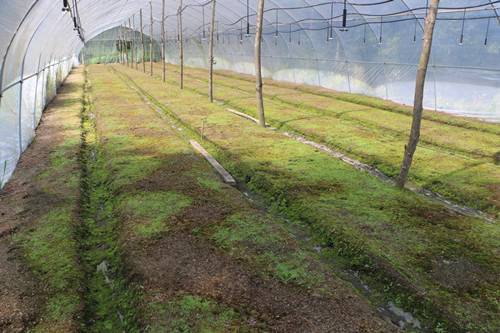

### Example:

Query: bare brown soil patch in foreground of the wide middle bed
xmin=130 ymin=232 xmax=389 ymax=332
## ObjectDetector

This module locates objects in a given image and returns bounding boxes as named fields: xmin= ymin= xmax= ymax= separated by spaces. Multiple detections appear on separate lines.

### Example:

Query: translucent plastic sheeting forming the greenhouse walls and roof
xmin=0 ymin=0 xmax=500 ymax=187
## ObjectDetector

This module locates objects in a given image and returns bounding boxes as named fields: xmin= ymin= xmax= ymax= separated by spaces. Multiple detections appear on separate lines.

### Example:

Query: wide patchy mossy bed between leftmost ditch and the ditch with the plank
xmin=89 ymin=62 xmax=390 ymax=332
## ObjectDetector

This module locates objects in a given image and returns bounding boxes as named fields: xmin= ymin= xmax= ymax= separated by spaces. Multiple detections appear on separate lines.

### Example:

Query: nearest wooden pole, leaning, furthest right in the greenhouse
xmin=396 ymin=0 xmax=439 ymax=188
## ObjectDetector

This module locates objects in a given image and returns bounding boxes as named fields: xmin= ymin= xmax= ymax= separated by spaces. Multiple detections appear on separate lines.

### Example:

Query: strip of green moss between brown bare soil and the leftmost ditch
xmin=9 ymin=68 xmax=84 ymax=332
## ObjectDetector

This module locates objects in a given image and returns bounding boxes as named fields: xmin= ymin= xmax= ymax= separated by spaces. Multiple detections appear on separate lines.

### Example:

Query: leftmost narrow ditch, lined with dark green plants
xmin=80 ymin=67 xmax=138 ymax=332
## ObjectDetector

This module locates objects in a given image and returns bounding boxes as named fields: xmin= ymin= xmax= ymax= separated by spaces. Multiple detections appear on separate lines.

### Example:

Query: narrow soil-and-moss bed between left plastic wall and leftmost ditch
xmin=0 ymin=68 xmax=84 ymax=332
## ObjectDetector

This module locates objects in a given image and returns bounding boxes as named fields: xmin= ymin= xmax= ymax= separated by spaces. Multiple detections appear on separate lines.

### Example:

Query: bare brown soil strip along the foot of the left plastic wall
xmin=0 ymin=70 xmax=81 ymax=332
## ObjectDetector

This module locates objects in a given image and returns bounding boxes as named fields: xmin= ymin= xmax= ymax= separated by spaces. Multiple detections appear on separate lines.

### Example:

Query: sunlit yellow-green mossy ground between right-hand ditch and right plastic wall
xmin=150 ymin=64 xmax=500 ymax=217
